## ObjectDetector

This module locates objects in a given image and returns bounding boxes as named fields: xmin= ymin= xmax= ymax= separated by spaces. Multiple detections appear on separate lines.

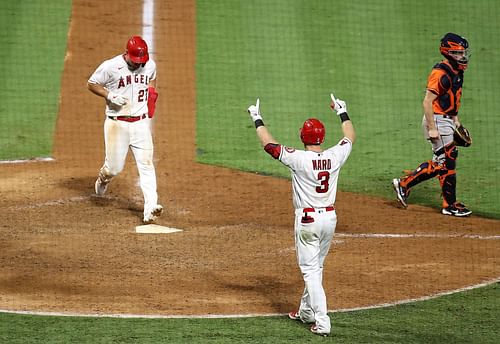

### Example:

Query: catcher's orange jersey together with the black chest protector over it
xmin=427 ymin=60 xmax=464 ymax=116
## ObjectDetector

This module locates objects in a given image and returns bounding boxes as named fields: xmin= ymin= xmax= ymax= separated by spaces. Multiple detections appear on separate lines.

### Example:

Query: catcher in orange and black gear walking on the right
xmin=392 ymin=33 xmax=472 ymax=216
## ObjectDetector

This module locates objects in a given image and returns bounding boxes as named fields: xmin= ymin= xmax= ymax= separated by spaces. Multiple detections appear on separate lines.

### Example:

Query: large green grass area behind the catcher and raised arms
xmin=197 ymin=0 xmax=500 ymax=218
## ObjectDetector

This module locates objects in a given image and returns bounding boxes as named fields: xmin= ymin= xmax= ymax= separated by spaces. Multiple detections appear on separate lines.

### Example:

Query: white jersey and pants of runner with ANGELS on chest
xmin=88 ymin=55 xmax=159 ymax=219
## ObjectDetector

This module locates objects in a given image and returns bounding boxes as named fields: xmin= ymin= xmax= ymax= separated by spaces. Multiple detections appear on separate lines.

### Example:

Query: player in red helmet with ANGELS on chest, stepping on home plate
xmin=87 ymin=36 xmax=163 ymax=223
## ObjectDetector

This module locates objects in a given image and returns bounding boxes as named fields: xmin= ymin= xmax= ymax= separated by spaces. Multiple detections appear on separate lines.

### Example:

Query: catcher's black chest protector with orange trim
xmin=434 ymin=62 xmax=464 ymax=116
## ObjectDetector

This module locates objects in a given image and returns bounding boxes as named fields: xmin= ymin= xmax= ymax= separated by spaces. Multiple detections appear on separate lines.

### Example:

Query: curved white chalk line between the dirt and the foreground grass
xmin=0 ymin=277 xmax=500 ymax=319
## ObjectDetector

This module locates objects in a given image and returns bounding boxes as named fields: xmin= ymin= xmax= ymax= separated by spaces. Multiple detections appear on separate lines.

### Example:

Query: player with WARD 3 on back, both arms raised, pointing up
xmin=248 ymin=94 xmax=355 ymax=336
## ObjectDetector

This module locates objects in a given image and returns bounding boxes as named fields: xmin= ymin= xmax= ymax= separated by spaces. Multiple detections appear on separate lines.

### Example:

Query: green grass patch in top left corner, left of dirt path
xmin=0 ymin=0 xmax=71 ymax=160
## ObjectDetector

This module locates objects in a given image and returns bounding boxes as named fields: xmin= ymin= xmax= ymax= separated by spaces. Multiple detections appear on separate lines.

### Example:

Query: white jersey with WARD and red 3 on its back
xmin=266 ymin=137 xmax=352 ymax=209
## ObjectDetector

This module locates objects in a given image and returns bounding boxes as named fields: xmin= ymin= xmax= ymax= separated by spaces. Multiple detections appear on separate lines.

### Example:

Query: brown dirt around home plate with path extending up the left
xmin=0 ymin=0 xmax=500 ymax=315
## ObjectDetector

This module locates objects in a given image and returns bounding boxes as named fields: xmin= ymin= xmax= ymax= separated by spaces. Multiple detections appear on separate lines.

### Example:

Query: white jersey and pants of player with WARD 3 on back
xmin=265 ymin=137 xmax=352 ymax=333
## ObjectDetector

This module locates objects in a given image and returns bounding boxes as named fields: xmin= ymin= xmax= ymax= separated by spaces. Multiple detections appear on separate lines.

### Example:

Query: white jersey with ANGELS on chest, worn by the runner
xmin=88 ymin=55 xmax=156 ymax=116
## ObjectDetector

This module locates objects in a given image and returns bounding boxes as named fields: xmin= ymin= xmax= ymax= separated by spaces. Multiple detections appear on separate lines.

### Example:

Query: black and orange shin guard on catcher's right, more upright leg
xmin=439 ymin=144 xmax=458 ymax=208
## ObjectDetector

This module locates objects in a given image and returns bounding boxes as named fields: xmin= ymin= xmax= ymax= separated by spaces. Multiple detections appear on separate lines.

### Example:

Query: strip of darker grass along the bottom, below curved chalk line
xmin=0 ymin=283 xmax=500 ymax=344
